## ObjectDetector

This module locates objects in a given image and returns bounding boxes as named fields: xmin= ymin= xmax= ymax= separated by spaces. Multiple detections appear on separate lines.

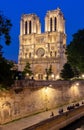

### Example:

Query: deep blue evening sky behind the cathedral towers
xmin=0 ymin=0 xmax=84 ymax=62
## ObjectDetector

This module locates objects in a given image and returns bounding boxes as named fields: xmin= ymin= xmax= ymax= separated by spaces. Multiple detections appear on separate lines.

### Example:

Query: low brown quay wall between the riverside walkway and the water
xmin=23 ymin=105 xmax=84 ymax=130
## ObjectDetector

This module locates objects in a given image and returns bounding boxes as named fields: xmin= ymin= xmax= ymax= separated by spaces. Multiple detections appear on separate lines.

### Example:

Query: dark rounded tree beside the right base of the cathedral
xmin=60 ymin=63 xmax=74 ymax=80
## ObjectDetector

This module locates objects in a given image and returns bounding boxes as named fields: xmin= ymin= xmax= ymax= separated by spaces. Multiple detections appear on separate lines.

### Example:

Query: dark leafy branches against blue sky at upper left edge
xmin=0 ymin=12 xmax=12 ymax=45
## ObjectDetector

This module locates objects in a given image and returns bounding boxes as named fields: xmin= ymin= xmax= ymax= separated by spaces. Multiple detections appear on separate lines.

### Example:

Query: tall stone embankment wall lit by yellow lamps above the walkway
xmin=0 ymin=80 xmax=84 ymax=124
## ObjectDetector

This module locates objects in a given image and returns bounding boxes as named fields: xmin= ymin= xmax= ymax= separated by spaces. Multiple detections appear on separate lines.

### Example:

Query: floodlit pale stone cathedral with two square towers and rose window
xmin=18 ymin=8 xmax=66 ymax=80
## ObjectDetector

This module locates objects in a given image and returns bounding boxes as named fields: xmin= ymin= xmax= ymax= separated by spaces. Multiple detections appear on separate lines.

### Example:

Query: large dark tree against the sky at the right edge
xmin=66 ymin=29 xmax=84 ymax=73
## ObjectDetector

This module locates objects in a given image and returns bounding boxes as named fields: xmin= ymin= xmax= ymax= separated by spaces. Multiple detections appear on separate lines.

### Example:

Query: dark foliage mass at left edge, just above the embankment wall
xmin=0 ymin=41 xmax=14 ymax=88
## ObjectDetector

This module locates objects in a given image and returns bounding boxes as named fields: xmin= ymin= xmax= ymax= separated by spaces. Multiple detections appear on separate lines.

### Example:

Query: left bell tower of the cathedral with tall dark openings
xmin=20 ymin=14 xmax=41 ymax=36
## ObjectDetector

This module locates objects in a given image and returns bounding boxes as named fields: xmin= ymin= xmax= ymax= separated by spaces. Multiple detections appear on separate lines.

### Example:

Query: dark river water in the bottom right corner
xmin=61 ymin=117 xmax=84 ymax=130
